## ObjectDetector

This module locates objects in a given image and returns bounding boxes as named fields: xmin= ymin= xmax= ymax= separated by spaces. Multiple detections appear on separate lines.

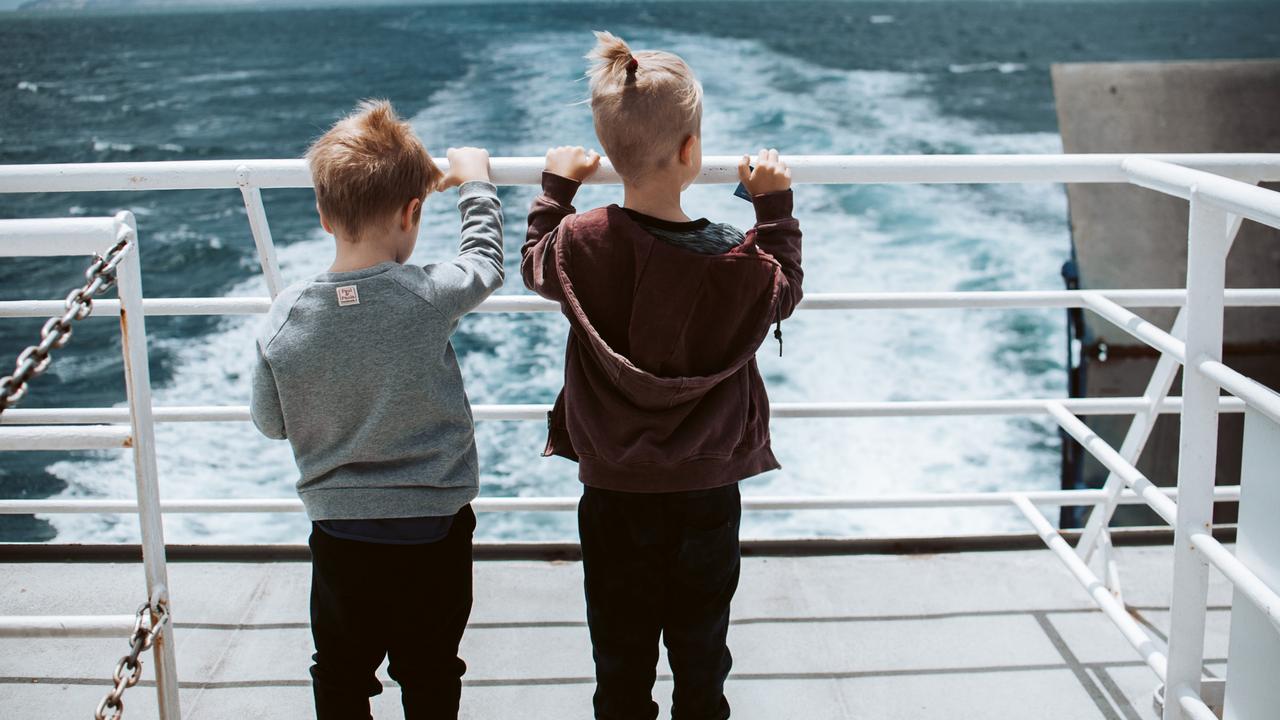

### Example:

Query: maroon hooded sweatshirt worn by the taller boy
xmin=520 ymin=173 xmax=804 ymax=492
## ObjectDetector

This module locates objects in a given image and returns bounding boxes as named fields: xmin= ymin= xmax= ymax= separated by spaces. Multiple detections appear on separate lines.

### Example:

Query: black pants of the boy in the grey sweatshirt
xmin=311 ymin=505 xmax=476 ymax=720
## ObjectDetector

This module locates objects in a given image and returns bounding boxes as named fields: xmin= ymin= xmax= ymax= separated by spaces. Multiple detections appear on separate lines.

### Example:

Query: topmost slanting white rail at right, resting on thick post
xmin=1123 ymin=158 xmax=1280 ymax=228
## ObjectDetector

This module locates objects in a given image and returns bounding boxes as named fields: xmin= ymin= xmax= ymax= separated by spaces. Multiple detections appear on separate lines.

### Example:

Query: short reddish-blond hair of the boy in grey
xmin=306 ymin=100 xmax=443 ymax=237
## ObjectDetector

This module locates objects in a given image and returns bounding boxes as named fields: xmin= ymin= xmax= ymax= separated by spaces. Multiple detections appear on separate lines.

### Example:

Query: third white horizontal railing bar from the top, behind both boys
xmin=0 ymin=397 xmax=1244 ymax=425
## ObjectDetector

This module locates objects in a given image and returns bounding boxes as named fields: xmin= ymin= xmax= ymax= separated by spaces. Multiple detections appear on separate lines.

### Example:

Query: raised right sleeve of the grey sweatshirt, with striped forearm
xmin=422 ymin=181 xmax=503 ymax=320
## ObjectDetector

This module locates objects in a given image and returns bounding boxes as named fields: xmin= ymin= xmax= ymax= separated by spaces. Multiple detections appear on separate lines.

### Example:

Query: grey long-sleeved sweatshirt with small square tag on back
xmin=251 ymin=182 xmax=503 ymax=520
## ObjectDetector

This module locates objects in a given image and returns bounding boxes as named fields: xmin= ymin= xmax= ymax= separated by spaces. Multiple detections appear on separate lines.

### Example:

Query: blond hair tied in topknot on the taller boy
xmin=586 ymin=32 xmax=703 ymax=178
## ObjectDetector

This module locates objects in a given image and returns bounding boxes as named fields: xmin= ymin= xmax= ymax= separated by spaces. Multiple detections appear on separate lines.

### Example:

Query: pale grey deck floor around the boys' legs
xmin=0 ymin=547 xmax=1230 ymax=720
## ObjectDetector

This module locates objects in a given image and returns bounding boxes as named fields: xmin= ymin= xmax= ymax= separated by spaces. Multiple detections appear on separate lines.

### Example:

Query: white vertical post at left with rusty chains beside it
xmin=115 ymin=213 xmax=182 ymax=720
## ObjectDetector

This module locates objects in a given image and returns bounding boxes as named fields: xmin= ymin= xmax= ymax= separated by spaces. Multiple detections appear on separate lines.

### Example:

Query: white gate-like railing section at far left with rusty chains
xmin=0 ymin=213 xmax=179 ymax=720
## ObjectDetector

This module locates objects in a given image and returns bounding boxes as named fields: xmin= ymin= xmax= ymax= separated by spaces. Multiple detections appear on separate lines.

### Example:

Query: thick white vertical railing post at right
xmin=1164 ymin=187 xmax=1230 ymax=720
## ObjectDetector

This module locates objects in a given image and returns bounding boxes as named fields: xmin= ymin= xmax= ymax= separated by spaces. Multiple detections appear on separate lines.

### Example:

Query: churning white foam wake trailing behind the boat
xmin=50 ymin=28 xmax=1069 ymax=542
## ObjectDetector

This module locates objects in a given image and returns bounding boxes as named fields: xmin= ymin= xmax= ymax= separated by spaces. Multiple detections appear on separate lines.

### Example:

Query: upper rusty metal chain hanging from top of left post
xmin=0 ymin=233 xmax=133 ymax=414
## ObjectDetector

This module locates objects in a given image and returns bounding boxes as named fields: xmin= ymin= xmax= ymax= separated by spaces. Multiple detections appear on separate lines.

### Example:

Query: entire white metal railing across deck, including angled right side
xmin=0 ymin=154 xmax=1280 ymax=720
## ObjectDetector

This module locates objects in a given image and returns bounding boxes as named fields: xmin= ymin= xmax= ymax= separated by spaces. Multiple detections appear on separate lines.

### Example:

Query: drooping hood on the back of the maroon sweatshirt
xmin=556 ymin=205 xmax=785 ymax=410
